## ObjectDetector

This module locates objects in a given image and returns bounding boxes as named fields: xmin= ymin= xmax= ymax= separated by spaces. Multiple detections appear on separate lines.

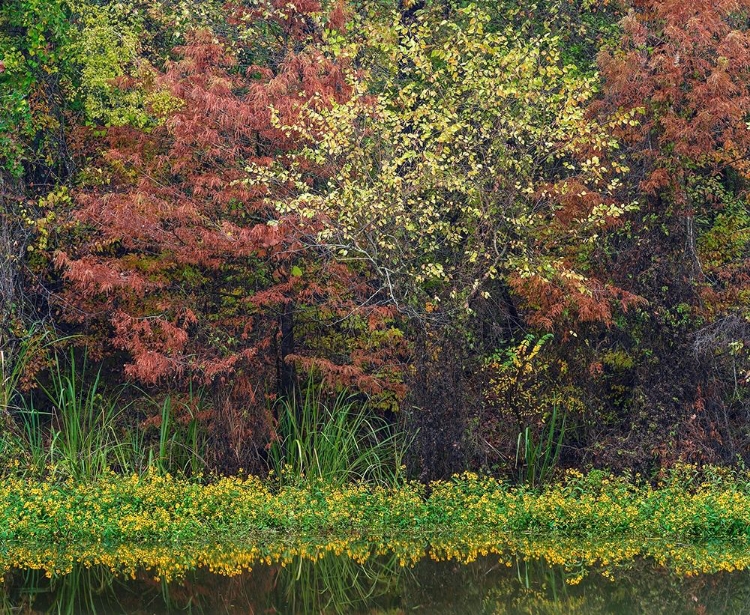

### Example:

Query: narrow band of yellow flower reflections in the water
xmin=3 ymin=536 xmax=750 ymax=585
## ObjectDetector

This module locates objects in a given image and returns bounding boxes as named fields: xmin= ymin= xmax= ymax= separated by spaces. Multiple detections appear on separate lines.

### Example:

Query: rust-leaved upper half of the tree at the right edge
xmin=594 ymin=0 xmax=750 ymax=318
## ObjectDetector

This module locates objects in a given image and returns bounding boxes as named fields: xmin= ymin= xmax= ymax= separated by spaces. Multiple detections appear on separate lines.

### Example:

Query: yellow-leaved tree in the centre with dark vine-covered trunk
xmin=253 ymin=5 xmax=635 ymax=474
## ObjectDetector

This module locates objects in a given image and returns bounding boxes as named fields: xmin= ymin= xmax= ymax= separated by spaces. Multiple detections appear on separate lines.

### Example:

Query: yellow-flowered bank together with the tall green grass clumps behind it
xmin=0 ymin=352 xmax=750 ymax=566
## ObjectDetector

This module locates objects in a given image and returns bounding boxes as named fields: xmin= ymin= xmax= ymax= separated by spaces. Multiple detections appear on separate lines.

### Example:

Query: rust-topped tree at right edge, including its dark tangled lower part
xmin=593 ymin=0 xmax=750 ymax=459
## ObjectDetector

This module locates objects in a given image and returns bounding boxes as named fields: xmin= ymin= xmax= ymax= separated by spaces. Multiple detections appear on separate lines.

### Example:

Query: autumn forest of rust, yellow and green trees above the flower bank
xmin=0 ymin=0 xmax=750 ymax=486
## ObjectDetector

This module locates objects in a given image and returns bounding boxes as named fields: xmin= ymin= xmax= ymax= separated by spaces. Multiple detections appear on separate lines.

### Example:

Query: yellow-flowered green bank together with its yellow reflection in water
xmin=0 ymin=467 xmax=750 ymax=583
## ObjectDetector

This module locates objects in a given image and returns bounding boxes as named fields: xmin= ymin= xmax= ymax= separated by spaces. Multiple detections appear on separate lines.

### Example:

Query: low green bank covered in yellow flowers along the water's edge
xmin=0 ymin=468 xmax=750 ymax=564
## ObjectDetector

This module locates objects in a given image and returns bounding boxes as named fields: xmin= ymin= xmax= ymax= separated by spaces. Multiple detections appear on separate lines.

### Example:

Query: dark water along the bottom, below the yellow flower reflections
xmin=0 ymin=553 xmax=750 ymax=615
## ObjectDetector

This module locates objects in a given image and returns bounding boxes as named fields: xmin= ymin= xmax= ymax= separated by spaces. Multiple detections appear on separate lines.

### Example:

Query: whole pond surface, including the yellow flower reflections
xmin=0 ymin=541 xmax=750 ymax=615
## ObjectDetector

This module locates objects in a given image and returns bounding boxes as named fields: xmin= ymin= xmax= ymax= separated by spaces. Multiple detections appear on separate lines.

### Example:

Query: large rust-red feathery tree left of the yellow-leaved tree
xmin=56 ymin=2 xmax=402 ymax=472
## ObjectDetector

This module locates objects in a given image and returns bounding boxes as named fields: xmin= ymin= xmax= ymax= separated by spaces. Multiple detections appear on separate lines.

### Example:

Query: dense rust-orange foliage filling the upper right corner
xmin=599 ymin=0 xmax=750 ymax=188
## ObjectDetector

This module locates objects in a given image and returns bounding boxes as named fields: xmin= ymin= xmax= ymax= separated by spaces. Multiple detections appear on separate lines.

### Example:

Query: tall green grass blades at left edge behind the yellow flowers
xmin=0 ymin=342 xmax=212 ymax=481
